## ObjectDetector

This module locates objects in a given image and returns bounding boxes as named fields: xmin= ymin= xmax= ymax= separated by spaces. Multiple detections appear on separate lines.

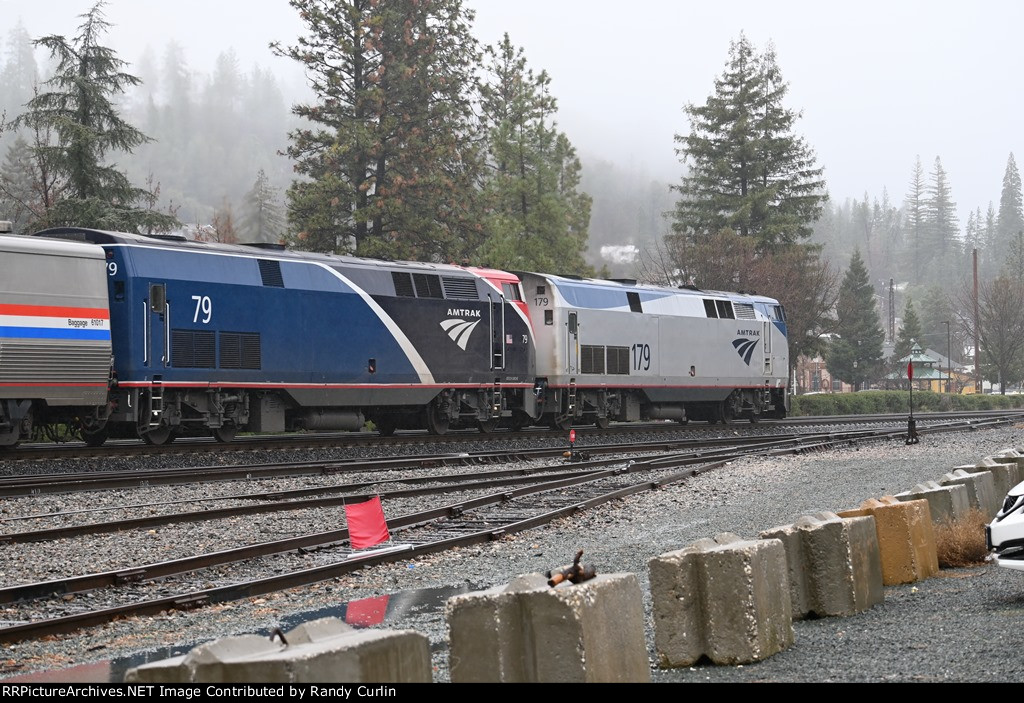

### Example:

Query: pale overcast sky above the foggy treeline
xmin=0 ymin=0 xmax=1024 ymax=227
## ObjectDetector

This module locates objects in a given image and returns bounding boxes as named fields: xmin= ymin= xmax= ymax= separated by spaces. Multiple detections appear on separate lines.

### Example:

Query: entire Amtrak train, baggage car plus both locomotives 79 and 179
xmin=0 ymin=227 xmax=788 ymax=447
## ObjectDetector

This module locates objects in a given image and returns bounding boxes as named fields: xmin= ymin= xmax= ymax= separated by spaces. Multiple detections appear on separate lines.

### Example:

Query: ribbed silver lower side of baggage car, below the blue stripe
xmin=0 ymin=341 xmax=111 ymax=385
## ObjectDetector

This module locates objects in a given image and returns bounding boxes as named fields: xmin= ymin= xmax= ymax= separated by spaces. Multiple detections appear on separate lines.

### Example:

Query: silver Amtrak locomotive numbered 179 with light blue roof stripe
xmin=520 ymin=273 xmax=788 ymax=428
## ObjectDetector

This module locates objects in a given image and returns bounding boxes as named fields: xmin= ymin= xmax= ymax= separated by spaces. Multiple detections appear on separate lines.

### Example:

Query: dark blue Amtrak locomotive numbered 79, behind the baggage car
xmin=18 ymin=228 xmax=534 ymax=444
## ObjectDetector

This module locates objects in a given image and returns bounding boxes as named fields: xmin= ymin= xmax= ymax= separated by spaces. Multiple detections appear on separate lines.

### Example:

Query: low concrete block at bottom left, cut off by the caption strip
xmin=125 ymin=618 xmax=432 ymax=684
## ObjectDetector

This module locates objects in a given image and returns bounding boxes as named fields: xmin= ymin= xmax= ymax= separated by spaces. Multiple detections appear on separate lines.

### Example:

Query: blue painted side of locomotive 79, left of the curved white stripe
xmin=108 ymin=246 xmax=421 ymax=384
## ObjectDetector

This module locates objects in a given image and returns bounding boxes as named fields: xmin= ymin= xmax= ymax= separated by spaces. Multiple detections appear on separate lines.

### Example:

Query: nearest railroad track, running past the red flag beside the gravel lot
xmin=0 ymin=416 xmax=1018 ymax=643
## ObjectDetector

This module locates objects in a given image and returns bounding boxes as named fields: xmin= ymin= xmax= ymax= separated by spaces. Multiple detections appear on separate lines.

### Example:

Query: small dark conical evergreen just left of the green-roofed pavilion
xmin=825 ymin=250 xmax=885 ymax=390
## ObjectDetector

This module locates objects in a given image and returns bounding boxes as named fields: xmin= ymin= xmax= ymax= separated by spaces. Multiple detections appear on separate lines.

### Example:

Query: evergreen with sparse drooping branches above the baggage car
xmin=15 ymin=1 xmax=177 ymax=231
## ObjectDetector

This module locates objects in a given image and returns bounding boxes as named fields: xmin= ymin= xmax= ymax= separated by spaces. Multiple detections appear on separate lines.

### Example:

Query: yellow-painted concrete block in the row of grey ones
xmin=839 ymin=496 xmax=939 ymax=585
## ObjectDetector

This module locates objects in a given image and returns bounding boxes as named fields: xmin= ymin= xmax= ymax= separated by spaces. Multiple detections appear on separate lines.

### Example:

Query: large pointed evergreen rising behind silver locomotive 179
xmin=673 ymin=35 xmax=826 ymax=252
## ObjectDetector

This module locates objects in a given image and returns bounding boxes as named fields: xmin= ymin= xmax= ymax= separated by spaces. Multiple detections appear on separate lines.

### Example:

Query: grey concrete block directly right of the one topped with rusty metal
xmin=649 ymin=533 xmax=794 ymax=667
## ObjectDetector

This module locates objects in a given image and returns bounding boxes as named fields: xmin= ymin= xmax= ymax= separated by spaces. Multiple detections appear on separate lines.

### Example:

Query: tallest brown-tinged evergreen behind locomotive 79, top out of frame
xmin=274 ymin=0 xmax=482 ymax=259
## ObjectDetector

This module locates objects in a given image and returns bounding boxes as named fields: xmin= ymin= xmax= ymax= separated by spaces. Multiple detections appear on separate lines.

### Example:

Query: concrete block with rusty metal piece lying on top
xmin=445 ymin=573 xmax=650 ymax=683
